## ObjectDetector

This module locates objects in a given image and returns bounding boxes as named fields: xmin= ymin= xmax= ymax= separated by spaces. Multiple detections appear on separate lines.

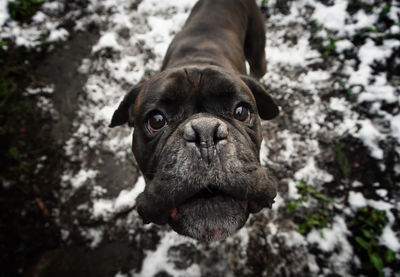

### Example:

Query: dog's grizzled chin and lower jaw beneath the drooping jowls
xmin=168 ymin=192 xmax=249 ymax=242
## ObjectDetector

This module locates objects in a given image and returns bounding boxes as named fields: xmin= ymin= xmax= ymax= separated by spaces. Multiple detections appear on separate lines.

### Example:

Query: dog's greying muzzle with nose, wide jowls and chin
xmin=137 ymin=114 xmax=276 ymax=241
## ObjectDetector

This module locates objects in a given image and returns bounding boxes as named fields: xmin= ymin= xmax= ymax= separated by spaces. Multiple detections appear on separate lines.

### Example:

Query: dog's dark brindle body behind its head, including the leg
xmin=161 ymin=0 xmax=266 ymax=79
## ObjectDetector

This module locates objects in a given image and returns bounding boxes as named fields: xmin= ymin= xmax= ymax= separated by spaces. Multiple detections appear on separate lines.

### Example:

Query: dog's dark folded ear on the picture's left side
xmin=109 ymin=85 xmax=142 ymax=128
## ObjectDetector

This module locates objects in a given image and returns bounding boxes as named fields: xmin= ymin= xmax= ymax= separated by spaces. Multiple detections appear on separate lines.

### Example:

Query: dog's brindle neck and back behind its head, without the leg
xmin=161 ymin=0 xmax=250 ymax=74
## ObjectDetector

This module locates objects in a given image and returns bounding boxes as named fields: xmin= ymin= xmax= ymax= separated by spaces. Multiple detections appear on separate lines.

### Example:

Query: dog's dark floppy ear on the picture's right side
xmin=240 ymin=75 xmax=279 ymax=120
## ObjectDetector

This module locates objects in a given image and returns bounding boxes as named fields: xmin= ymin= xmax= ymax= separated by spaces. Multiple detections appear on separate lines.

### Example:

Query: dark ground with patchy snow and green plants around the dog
xmin=0 ymin=0 xmax=400 ymax=277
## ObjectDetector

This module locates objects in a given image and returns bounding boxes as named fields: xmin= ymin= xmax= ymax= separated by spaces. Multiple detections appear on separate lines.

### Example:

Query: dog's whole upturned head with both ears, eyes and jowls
xmin=110 ymin=67 xmax=278 ymax=241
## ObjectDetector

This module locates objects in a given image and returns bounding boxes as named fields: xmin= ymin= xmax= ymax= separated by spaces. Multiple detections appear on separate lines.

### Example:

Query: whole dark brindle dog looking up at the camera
xmin=110 ymin=0 xmax=279 ymax=242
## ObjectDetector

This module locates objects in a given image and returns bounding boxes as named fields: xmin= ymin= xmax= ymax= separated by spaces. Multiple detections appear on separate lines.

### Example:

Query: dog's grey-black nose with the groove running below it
xmin=183 ymin=117 xmax=228 ymax=163
